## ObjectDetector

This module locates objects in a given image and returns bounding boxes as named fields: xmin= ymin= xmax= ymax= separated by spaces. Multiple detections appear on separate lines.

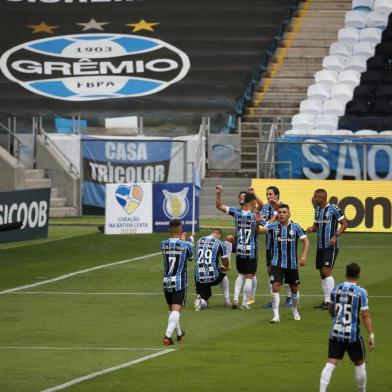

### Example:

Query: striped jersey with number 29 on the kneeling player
xmin=195 ymin=236 xmax=227 ymax=283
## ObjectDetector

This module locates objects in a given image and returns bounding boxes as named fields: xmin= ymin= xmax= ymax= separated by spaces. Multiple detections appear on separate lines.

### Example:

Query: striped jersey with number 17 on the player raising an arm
xmin=227 ymin=207 xmax=257 ymax=259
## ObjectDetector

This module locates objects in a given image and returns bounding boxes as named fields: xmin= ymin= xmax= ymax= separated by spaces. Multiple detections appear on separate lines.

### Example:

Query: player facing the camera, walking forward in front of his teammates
xmin=260 ymin=204 xmax=309 ymax=324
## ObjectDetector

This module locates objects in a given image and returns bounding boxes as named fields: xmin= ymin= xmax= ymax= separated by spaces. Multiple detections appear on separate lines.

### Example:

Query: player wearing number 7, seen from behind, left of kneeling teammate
xmin=161 ymin=219 xmax=193 ymax=345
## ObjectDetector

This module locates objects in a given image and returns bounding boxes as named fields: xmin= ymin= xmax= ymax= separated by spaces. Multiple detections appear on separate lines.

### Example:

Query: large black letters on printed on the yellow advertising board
xmin=329 ymin=196 xmax=392 ymax=229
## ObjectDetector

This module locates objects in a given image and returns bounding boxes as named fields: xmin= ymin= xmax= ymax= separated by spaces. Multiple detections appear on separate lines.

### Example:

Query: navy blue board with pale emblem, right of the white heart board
xmin=153 ymin=184 xmax=199 ymax=232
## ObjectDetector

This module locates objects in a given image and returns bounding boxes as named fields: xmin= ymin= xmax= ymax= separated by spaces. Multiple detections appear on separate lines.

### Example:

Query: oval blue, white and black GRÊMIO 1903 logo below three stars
xmin=0 ymin=33 xmax=190 ymax=101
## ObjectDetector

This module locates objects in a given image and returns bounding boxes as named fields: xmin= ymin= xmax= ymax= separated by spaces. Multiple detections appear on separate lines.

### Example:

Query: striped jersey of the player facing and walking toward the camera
xmin=266 ymin=221 xmax=306 ymax=269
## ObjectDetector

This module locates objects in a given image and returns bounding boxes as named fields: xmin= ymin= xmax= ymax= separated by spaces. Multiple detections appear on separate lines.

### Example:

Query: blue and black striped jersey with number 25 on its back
xmin=329 ymin=282 xmax=369 ymax=343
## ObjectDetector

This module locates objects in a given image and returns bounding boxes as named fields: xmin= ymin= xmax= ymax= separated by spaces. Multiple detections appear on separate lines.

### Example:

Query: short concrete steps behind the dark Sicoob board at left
xmin=25 ymin=169 xmax=77 ymax=218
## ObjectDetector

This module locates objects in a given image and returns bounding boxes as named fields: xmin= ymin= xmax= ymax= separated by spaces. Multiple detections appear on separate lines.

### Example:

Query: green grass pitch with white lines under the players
xmin=0 ymin=220 xmax=392 ymax=392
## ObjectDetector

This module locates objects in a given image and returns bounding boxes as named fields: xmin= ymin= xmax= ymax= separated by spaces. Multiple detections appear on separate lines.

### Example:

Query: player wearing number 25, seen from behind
xmin=320 ymin=263 xmax=375 ymax=392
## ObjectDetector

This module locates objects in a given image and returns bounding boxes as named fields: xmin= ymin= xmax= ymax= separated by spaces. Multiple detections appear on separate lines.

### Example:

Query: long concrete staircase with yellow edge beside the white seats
xmin=241 ymin=0 xmax=352 ymax=173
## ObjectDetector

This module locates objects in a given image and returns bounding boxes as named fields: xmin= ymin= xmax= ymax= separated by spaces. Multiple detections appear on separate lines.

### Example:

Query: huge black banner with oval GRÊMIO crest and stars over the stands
xmin=0 ymin=0 xmax=290 ymax=126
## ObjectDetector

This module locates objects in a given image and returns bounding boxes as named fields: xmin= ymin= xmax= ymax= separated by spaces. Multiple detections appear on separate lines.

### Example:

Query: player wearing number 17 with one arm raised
xmin=216 ymin=185 xmax=260 ymax=309
